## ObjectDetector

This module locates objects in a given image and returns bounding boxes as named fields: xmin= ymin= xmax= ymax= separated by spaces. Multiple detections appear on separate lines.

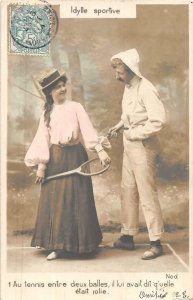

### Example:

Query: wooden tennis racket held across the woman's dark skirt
xmin=45 ymin=157 xmax=110 ymax=181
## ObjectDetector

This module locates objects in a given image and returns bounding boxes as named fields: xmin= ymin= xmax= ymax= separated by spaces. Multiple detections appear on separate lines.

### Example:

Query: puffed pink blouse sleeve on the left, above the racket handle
xmin=24 ymin=115 xmax=50 ymax=169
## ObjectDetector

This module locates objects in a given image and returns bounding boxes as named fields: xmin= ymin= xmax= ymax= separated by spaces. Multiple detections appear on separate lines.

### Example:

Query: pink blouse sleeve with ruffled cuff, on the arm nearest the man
xmin=76 ymin=103 xmax=111 ymax=152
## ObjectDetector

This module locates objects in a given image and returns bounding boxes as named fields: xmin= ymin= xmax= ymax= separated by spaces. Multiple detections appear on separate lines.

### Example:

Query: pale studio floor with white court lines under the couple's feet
xmin=7 ymin=229 xmax=189 ymax=273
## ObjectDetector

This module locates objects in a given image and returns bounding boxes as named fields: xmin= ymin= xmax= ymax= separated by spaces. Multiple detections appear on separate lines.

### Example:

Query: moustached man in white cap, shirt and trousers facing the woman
xmin=108 ymin=49 xmax=165 ymax=260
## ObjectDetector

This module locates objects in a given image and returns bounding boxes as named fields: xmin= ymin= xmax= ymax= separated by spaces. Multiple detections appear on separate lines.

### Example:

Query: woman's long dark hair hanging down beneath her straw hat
xmin=43 ymin=76 xmax=67 ymax=128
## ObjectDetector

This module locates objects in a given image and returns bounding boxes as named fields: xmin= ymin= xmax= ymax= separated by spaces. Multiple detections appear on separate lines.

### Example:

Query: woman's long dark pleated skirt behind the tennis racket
xmin=31 ymin=144 xmax=102 ymax=253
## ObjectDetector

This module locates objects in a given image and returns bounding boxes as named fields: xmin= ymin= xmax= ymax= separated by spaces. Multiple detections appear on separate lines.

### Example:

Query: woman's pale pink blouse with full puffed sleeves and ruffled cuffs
xmin=25 ymin=100 xmax=111 ymax=169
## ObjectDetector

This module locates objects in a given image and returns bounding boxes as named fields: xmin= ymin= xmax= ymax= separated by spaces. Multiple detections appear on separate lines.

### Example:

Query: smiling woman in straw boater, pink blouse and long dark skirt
xmin=25 ymin=70 xmax=110 ymax=260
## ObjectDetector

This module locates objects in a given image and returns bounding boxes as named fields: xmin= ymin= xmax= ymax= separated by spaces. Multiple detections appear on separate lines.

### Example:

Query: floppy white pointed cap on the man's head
xmin=111 ymin=49 xmax=142 ymax=78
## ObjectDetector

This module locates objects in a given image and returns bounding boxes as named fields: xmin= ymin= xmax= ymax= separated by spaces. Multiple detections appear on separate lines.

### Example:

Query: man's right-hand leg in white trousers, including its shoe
xmin=132 ymin=142 xmax=163 ymax=259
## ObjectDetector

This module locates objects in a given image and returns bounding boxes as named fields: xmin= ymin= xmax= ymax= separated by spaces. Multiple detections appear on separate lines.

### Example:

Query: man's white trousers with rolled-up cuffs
xmin=121 ymin=137 xmax=163 ymax=241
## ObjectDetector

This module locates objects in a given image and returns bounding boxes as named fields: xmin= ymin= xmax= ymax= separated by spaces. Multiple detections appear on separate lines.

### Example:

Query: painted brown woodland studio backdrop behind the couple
xmin=8 ymin=5 xmax=188 ymax=246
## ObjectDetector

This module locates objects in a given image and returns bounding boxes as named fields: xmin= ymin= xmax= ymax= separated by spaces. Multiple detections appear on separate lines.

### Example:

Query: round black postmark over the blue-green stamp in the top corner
xmin=10 ymin=2 xmax=58 ymax=49
